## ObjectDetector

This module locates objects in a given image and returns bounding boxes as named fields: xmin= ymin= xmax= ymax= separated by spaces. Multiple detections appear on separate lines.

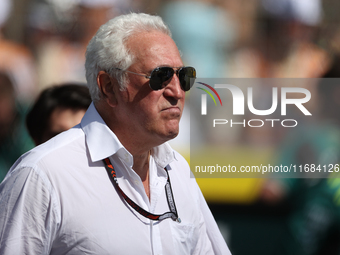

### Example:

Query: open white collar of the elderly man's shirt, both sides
xmin=80 ymin=103 xmax=177 ymax=168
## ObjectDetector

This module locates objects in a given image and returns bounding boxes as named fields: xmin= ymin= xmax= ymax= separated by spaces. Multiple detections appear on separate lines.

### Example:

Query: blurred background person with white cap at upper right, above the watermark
xmin=230 ymin=0 xmax=329 ymax=78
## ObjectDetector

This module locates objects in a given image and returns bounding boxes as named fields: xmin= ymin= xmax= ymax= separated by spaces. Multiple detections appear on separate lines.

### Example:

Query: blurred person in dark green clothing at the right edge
xmin=261 ymin=56 xmax=340 ymax=255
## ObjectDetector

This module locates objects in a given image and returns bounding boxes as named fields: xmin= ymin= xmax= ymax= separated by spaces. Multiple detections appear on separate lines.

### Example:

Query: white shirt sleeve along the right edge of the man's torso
xmin=198 ymin=184 xmax=231 ymax=255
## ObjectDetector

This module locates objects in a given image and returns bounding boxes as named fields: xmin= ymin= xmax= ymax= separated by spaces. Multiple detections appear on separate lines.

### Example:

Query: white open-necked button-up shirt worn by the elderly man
xmin=0 ymin=104 xmax=230 ymax=255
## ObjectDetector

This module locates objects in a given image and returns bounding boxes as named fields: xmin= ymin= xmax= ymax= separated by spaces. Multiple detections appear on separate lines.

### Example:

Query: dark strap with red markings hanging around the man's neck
xmin=103 ymin=158 xmax=181 ymax=223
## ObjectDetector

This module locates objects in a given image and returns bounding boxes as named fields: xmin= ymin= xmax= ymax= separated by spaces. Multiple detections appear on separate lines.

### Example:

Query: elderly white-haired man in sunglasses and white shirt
xmin=0 ymin=14 xmax=230 ymax=255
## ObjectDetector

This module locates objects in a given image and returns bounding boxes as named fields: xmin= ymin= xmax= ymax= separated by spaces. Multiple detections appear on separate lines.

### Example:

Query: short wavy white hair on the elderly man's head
xmin=85 ymin=13 xmax=171 ymax=102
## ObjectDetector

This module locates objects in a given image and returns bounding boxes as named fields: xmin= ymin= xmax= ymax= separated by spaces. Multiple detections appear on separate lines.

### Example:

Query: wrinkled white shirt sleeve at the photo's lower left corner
xmin=0 ymin=167 xmax=58 ymax=255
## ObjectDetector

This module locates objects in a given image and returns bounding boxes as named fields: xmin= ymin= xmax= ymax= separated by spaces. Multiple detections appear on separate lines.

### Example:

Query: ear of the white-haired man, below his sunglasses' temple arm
xmin=97 ymin=71 xmax=118 ymax=107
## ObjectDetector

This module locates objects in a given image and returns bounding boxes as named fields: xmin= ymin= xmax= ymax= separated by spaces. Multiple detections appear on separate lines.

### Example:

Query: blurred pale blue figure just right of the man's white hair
xmin=161 ymin=0 xmax=236 ymax=78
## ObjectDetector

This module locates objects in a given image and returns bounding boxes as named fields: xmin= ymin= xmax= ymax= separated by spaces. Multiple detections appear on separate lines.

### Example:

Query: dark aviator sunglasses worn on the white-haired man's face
xmin=116 ymin=66 xmax=196 ymax=91
